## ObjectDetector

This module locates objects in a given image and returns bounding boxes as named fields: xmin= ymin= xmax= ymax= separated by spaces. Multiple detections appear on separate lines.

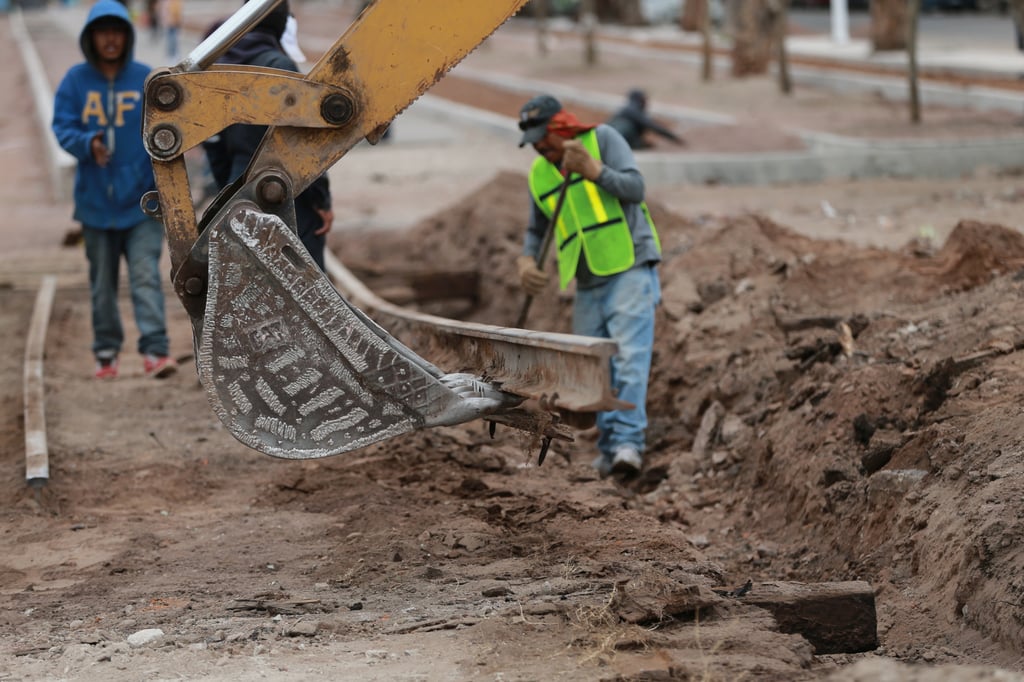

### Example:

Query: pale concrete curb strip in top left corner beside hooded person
xmin=9 ymin=7 xmax=78 ymax=202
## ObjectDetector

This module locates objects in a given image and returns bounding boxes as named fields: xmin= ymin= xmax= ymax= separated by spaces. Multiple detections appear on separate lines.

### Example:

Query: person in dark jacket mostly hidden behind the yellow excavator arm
xmin=203 ymin=0 xmax=334 ymax=269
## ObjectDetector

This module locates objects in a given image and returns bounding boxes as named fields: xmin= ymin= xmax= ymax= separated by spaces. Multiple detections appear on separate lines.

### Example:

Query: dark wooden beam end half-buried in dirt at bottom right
xmin=740 ymin=581 xmax=879 ymax=653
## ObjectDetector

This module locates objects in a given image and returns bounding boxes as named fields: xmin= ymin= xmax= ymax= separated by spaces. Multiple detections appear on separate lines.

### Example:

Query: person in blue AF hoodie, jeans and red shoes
xmin=52 ymin=0 xmax=176 ymax=379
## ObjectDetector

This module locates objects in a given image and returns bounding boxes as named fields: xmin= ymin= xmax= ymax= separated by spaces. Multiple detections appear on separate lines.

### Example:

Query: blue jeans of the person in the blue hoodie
xmin=82 ymin=219 xmax=170 ymax=357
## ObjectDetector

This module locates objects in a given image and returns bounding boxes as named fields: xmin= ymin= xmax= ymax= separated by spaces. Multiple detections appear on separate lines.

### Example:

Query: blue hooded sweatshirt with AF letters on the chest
xmin=52 ymin=0 xmax=156 ymax=229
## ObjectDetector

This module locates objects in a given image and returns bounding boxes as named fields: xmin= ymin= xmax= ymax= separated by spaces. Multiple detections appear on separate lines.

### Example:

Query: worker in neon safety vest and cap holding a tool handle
xmin=516 ymin=94 xmax=662 ymax=476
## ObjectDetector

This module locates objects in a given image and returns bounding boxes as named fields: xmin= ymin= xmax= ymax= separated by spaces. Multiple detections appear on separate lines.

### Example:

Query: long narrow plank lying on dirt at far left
xmin=25 ymin=274 xmax=57 ymax=486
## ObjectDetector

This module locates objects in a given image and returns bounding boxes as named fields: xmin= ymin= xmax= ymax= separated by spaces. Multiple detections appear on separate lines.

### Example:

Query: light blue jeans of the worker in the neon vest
xmin=572 ymin=267 xmax=662 ymax=460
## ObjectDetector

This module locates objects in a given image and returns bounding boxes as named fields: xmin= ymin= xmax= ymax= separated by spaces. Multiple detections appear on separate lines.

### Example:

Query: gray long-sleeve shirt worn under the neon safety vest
xmin=522 ymin=124 xmax=662 ymax=289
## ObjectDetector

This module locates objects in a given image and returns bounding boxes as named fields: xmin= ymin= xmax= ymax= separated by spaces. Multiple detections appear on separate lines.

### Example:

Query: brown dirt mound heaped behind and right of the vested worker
xmin=344 ymin=174 xmax=1024 ymax=660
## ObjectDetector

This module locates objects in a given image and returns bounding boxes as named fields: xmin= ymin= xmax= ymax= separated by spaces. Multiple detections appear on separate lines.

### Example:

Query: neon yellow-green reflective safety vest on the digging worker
xmin=529 ymin=130 xmax=662 ymax=290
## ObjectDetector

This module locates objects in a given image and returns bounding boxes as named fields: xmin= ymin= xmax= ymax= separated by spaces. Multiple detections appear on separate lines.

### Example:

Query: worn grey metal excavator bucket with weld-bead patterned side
xmin=197 ymin=204 xmax=540 ymax=459
